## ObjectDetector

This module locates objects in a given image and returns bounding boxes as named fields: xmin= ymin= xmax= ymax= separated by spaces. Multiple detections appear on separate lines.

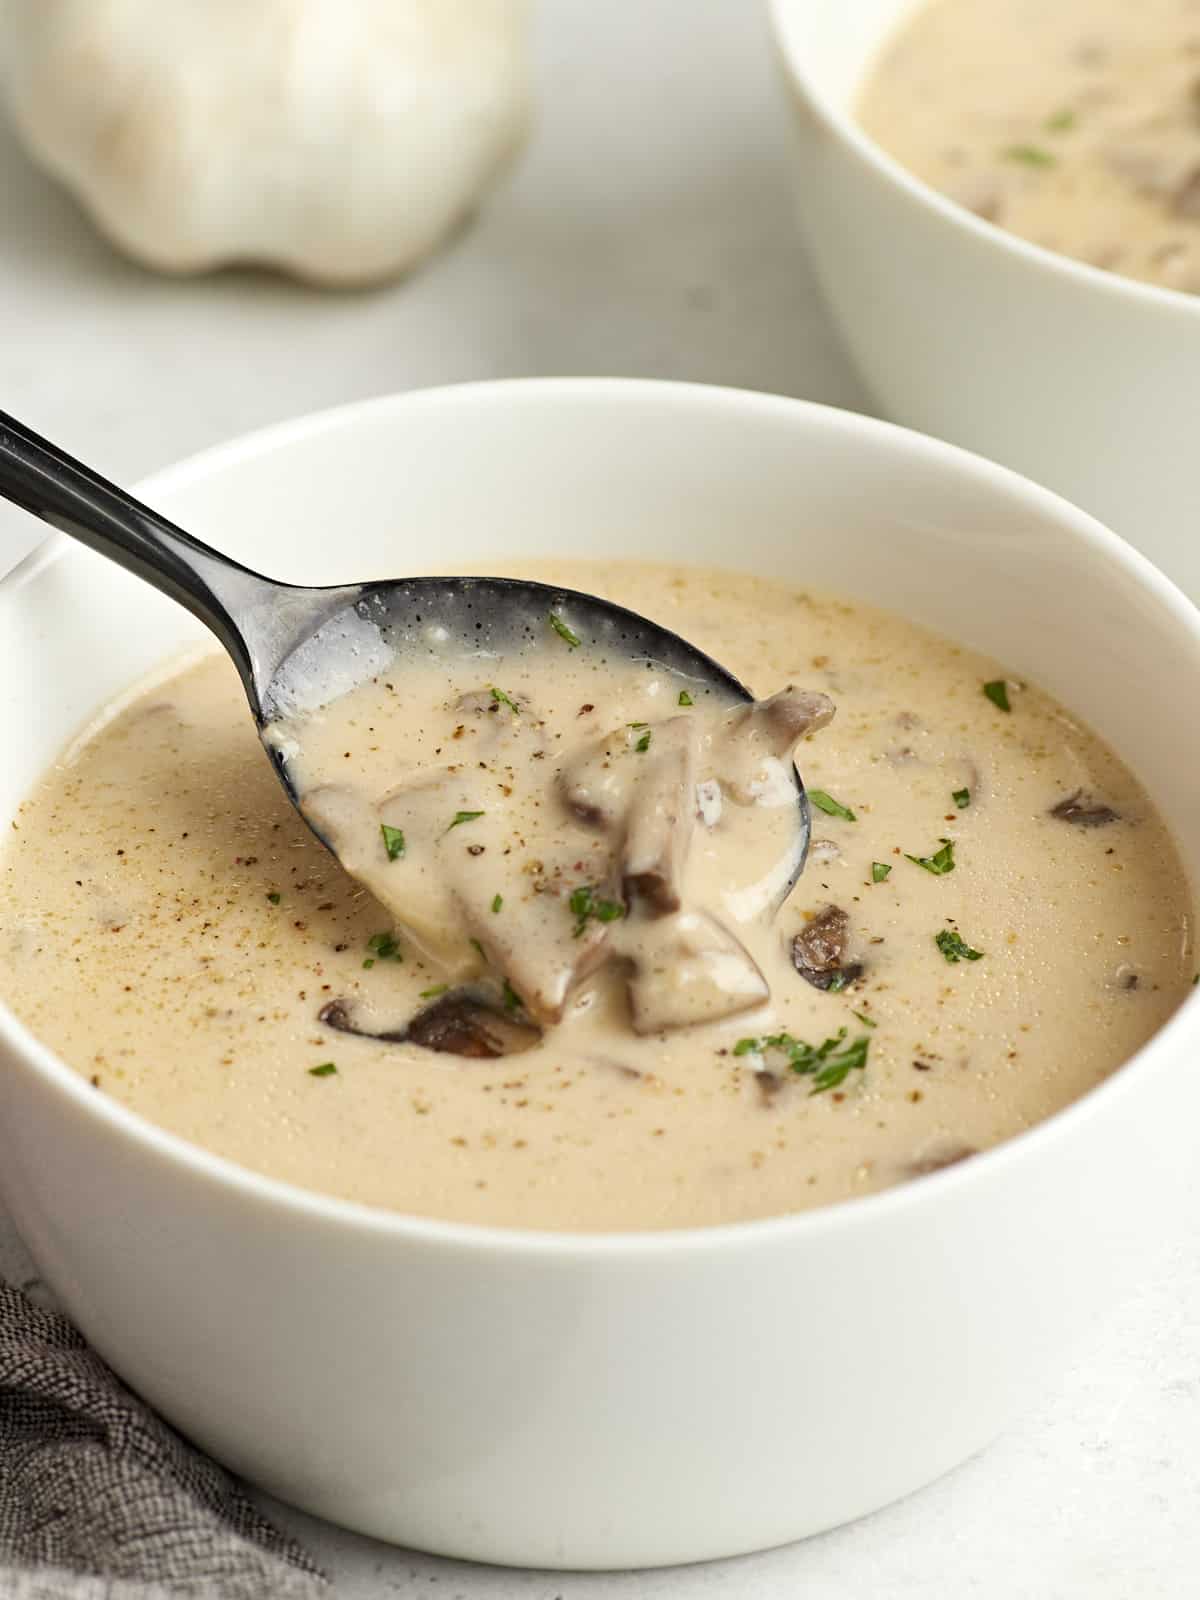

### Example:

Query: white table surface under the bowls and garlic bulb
xmin=0 ymin=0 xmax=1200 ymax=1600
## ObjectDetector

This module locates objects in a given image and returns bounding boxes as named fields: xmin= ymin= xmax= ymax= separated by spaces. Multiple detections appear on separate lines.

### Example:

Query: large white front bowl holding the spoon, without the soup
xmin=0 ymin=381 xmax=1200 ymax=1568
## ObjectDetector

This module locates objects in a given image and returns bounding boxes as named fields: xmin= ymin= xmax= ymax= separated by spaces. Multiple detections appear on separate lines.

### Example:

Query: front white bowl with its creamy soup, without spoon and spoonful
xmin=0 ymin=379 xmax=1200 ymax=1568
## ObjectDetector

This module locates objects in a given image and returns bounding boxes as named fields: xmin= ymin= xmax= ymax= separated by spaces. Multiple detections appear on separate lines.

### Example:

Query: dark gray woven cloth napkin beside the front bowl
xmin=0 ymin=1282 xmax=330 ymax=1600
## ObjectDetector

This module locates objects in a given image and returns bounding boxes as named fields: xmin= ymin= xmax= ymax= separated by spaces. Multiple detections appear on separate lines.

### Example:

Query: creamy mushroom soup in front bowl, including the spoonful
xmin=0 ymin=563 xmax=1192 ymax=1230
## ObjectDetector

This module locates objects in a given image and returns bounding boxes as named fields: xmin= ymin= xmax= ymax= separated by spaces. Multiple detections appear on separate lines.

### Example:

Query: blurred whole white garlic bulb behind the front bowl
xmin=0 ymin=0 xmax=530 ymax=285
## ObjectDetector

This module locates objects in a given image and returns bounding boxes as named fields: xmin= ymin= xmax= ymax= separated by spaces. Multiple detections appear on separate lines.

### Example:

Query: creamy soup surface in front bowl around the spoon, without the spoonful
xmin=0 ymin=563 xmax=1192 ymax=1230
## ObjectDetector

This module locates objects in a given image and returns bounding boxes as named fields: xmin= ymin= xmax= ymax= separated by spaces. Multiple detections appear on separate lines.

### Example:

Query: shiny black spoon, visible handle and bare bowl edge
xmin=0 ymin=411 xmax=810 ymax=890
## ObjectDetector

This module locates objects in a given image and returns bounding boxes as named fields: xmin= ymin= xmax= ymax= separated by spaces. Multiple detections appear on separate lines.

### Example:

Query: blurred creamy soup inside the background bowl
xmin=859 ymin=0 xmax=1200 ymax=293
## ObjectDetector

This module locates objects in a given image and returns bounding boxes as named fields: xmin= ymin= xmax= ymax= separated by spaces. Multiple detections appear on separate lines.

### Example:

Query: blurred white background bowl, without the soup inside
xmin=770 ymin=0 xmax=1200 ymax=597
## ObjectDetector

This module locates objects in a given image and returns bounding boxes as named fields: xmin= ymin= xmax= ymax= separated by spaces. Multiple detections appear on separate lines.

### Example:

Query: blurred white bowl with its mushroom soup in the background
xmin=771 ymin=0 xmax=1200 ymax=595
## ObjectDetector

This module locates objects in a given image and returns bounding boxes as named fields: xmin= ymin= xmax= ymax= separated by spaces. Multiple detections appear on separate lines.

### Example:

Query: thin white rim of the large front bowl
xmin=0 ymin=378 xmax=1200 ymax=1262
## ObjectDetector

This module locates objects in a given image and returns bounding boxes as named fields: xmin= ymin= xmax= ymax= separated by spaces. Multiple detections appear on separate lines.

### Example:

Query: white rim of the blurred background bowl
xmin=766 ymin=0 xmax=1200 ymax=317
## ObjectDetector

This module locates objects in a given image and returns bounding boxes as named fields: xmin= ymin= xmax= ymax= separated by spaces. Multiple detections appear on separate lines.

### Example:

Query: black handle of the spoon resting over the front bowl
xmin=0 ymin=411 xmax=286 ymax=686
